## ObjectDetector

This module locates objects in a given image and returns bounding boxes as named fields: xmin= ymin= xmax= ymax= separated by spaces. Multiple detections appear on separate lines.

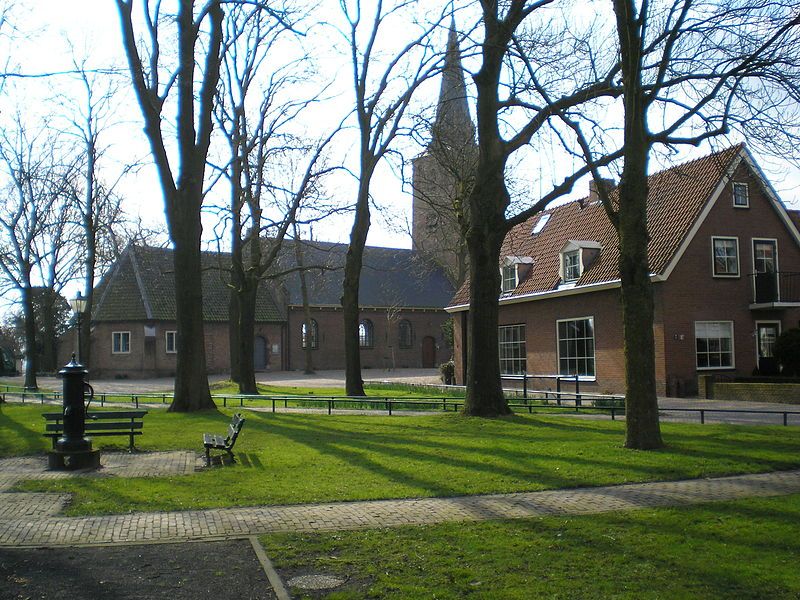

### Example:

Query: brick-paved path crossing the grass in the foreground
xmin=0 ymin=453 xmax=800 ymax=546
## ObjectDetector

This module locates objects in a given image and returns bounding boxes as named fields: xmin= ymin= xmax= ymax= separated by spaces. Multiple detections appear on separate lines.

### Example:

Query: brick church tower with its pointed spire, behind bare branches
xmin=411 ymin=21 xmax=478 ymax=287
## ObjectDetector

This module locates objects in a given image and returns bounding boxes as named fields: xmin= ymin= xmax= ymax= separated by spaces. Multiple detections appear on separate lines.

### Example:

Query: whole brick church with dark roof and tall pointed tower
xmin=74 ymin=30 xmax=468 ymax=378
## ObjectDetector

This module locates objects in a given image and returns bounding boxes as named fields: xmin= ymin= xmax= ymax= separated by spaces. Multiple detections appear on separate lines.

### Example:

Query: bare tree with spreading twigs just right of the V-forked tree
xmin=216 ymin=6 xmax=335 ymax=394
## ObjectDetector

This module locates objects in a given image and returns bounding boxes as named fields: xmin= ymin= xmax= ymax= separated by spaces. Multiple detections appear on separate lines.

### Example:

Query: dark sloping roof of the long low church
xmin=92 ymin=240 xmax=453 ymax=323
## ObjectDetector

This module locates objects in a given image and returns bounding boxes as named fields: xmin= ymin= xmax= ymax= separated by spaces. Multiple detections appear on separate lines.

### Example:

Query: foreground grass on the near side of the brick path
xmin=262 ymin=495 xmax=800 ymax=600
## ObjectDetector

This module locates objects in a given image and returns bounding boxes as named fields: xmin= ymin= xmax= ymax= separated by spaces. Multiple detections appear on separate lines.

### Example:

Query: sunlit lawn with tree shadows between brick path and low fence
xmin=6 ymin=404 xmax=800 ymax=515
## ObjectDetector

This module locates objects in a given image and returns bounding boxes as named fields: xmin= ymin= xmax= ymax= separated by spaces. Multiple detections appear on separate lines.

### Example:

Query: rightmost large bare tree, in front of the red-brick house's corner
xmin=561 ymin=0 xmax=800 ymax=449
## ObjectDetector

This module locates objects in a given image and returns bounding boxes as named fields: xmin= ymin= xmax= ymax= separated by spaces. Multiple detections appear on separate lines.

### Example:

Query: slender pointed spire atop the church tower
xmin=431 ymin=18 xmax=475 ymax=150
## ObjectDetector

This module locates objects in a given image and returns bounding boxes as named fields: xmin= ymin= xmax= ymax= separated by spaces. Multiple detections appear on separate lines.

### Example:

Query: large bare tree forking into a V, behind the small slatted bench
xmin=117 ymin=0 xmax=224 ymax=411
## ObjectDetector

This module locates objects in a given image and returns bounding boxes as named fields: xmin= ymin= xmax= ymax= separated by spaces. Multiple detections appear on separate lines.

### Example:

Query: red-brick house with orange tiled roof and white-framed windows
xmin=447 ymin=145 xmax=800 ymax=395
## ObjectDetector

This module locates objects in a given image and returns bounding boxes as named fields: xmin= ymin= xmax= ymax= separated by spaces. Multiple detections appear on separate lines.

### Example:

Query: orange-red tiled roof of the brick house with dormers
xmin=451 ymin=144 xmax=743 ymax=306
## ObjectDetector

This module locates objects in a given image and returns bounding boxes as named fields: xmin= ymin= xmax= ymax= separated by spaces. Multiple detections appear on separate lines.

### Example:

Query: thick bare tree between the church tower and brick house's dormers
xmin=464 ymin=0 xmax=619 ymax=416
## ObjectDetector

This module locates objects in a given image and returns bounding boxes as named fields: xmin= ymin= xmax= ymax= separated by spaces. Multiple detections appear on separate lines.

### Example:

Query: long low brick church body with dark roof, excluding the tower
xmin=81 ymin=242 xmax=453 ymax=378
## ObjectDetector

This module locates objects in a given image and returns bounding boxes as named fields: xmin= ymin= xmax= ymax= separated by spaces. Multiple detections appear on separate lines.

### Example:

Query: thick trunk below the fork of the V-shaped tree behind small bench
xmin=169 ymin=202 xmax=216 ymax=412
